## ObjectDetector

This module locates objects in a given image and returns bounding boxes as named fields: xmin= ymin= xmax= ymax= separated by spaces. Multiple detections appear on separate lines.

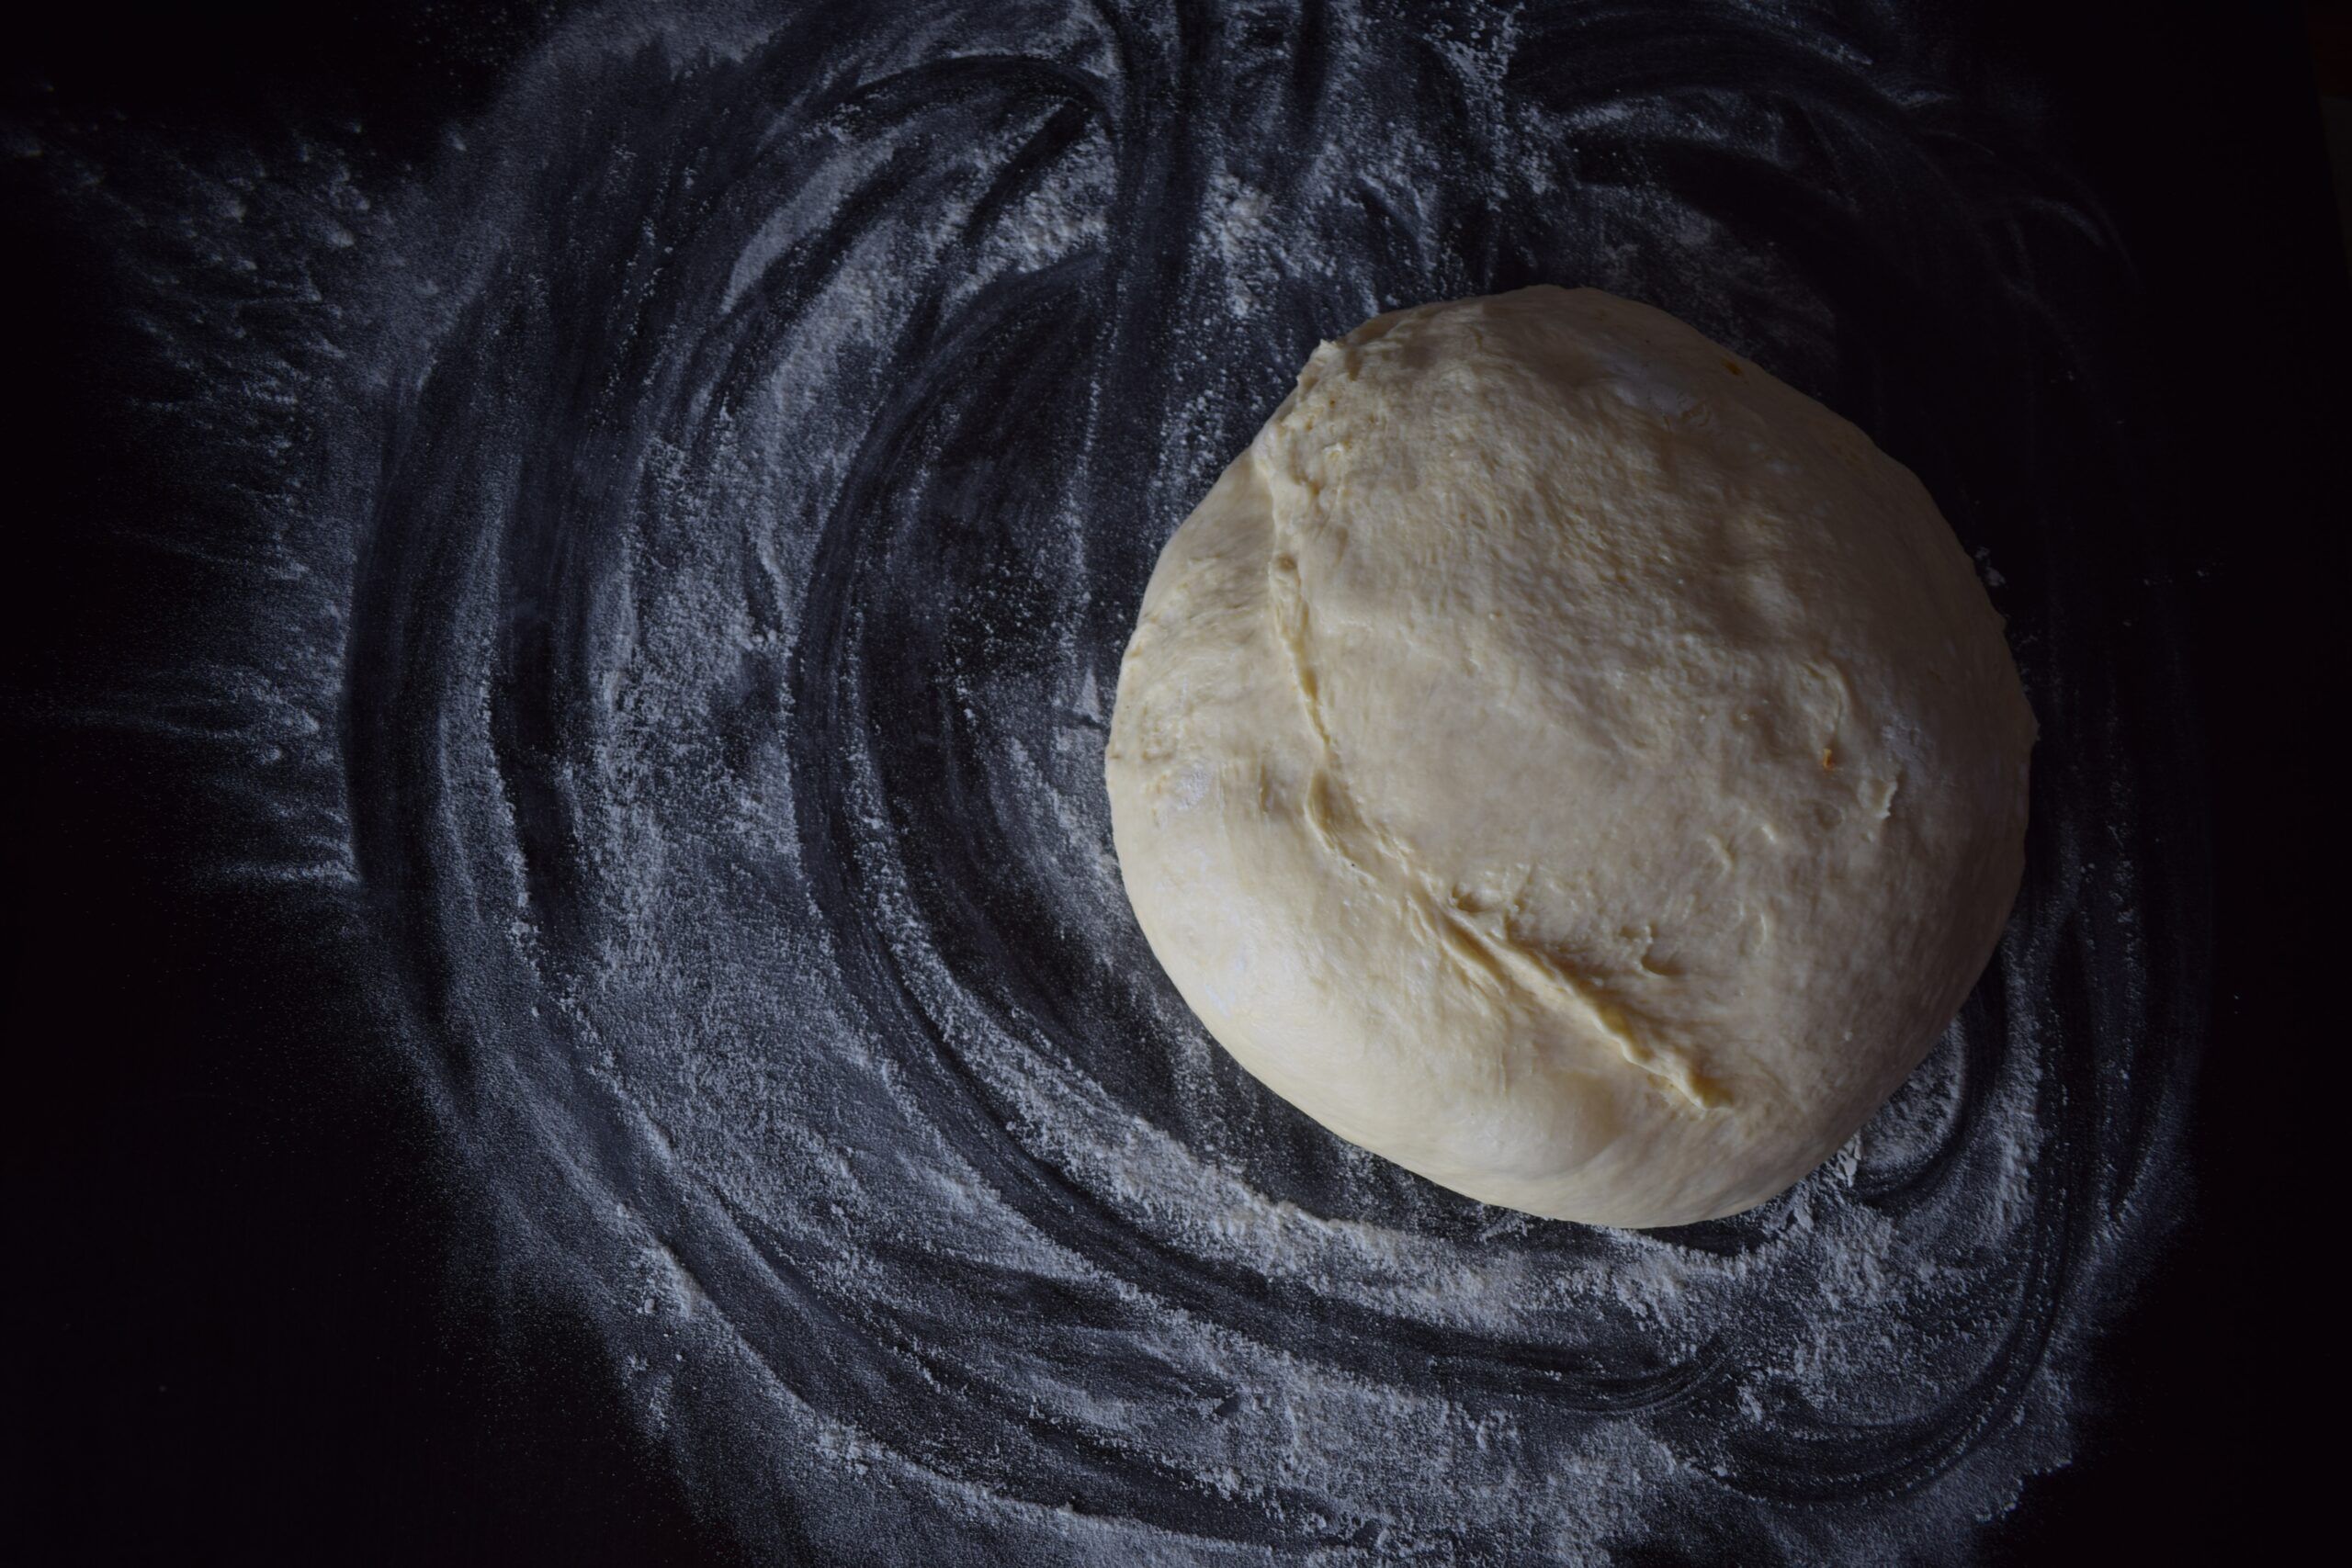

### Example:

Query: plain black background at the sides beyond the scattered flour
xmin=0 ymin=3 xmax=2352 ymax=1563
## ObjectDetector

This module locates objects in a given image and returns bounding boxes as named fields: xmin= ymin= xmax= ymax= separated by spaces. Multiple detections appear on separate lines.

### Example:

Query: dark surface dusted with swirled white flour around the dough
xmin=18 ymin=3 xmax=2201 ymax=1563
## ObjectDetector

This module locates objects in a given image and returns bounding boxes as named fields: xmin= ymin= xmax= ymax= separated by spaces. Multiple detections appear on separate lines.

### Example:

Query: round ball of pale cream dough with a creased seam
xmin=1108 ymin=287 xmax=2034 ymax=1224
